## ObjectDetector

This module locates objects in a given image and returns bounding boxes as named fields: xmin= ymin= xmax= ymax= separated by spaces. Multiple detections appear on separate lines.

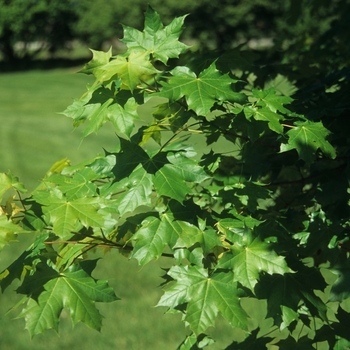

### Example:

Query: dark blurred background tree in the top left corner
xmin=0 ymin=0 xmax=77 ymax=62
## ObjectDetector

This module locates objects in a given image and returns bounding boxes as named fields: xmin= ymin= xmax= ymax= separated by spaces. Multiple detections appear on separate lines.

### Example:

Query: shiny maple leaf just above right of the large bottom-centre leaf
xmin=218 ymin=237 xmax=293 ymax=292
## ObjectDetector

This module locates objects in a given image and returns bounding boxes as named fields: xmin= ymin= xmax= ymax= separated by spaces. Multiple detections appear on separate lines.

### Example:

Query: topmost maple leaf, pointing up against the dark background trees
xmin=122 ymin=6 xmax=188 ymax=64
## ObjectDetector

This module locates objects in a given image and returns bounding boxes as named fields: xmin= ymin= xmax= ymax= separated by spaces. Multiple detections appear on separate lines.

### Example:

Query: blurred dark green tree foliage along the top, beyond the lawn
xmin=0 ymin=0 xmax=349 ymax=62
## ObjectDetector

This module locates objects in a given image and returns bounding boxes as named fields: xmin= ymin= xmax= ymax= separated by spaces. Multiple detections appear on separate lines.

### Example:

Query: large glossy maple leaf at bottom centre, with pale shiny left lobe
xmin=157 ymin=266 xmax=248 ymax=335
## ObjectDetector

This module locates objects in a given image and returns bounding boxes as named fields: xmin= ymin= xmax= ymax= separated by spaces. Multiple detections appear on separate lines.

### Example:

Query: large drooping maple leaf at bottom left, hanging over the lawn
xmin=19 ymin=261 xmax=117 ymax=337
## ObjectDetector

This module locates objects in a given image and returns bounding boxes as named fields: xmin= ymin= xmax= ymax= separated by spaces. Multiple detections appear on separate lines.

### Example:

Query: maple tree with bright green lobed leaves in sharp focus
xmin=0 ymin=8 xmax=350 ymax=350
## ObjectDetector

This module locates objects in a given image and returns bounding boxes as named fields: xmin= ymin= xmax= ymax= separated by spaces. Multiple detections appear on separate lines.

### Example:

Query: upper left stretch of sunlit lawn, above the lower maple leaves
xmin=0 ymin=70 xmax=116 ymax=189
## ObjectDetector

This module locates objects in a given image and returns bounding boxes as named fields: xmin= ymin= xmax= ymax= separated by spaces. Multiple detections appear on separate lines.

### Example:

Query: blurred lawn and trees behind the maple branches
xmin=0 ymin=0 xmax=350 ymax=350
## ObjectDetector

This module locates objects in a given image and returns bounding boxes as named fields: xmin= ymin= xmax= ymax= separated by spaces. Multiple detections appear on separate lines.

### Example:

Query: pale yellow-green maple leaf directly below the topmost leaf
xmin=97 ymin=51 xmax=159 ymax=91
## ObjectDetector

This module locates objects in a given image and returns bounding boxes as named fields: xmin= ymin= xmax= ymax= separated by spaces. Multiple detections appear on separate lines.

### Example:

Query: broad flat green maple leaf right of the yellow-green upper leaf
xmin=154 ymin=62 xmax=245 ymax=116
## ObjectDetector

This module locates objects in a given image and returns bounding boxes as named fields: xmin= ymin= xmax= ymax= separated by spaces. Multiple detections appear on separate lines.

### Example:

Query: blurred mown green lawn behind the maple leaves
xmin=0 ymin=69 xmax=238 ymax=350
